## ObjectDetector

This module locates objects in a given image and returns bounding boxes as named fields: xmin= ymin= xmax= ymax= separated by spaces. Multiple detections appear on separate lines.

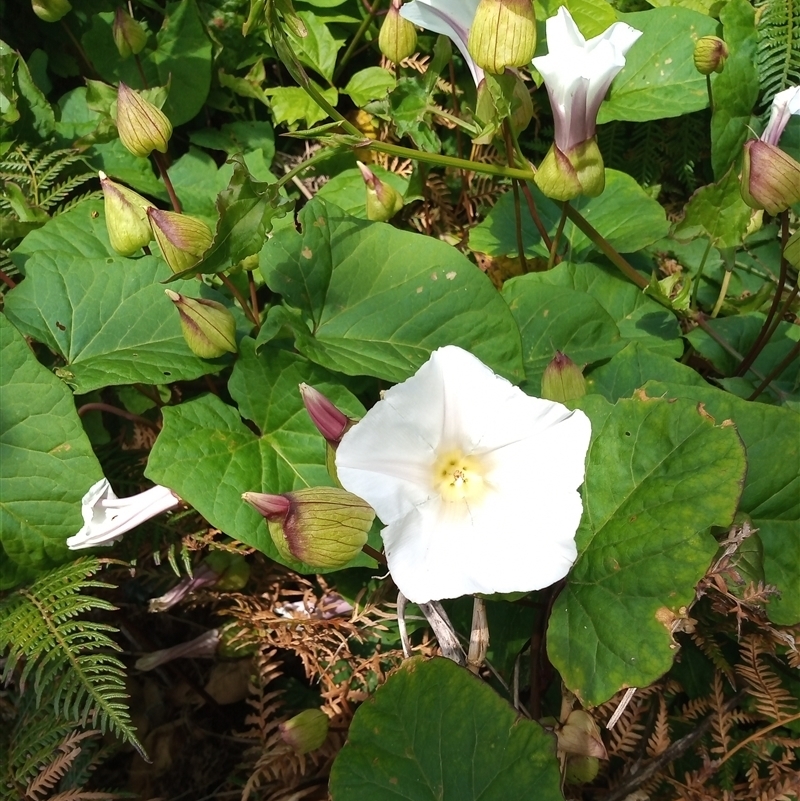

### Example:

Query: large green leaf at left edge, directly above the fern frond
xmin=0 ymin=315 xmax=103 ymax=589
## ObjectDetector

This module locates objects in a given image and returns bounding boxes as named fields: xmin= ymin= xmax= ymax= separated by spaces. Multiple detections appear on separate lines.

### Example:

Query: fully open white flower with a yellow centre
xmin=336 ymin=346 xmax=591 ymax=603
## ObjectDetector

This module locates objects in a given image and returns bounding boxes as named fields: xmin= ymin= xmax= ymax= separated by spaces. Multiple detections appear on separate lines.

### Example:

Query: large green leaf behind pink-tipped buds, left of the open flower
xmin=145 ymin=338 xmax=374 ymax=572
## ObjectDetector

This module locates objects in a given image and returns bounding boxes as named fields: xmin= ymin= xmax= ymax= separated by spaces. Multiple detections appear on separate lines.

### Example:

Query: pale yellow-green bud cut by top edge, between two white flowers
xmin=467 ymin=0 xmax=536 ymax=74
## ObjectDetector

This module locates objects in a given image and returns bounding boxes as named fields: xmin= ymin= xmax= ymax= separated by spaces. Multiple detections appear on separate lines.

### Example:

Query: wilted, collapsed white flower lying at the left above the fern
xmin=67 ymin=478 xmax=180 ymax=551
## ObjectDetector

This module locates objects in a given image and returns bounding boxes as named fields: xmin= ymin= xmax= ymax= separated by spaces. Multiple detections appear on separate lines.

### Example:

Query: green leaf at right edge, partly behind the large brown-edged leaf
xmin=645 ymin=382 xmax=800 ymax=625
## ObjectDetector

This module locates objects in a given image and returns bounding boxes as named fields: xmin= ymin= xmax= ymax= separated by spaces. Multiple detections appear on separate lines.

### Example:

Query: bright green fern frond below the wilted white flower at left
xmin=0 ymin=559 xmax=144 ymax=754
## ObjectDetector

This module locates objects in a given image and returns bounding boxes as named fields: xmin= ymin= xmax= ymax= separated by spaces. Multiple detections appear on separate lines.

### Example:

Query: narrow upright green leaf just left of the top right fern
xmin=711 ymin=0 xmax=758 ymax=178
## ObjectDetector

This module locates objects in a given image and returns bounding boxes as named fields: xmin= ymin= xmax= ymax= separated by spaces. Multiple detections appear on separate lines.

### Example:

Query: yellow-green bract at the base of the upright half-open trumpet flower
xmin=534 ymin=137 xmax=606 ymax=200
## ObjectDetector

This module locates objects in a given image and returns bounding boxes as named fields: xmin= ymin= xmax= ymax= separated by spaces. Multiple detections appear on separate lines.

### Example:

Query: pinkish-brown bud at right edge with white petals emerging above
xmin=741 ymin=139 xmax=800 ymax=215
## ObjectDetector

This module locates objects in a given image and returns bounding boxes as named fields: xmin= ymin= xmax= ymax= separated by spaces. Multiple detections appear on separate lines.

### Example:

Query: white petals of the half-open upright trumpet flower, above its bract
xmin=533 ymin=6 xmax=642 ymax=153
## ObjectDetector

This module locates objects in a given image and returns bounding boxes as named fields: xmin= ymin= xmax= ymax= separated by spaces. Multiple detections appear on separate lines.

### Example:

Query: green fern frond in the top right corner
xmin=756 ymin=0 xmax=800 ymax=106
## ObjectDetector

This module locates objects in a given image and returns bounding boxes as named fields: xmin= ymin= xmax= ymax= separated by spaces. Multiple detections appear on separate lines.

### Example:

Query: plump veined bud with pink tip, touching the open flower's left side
xmin=242 ymin=487 xmax=375 ymax=569
